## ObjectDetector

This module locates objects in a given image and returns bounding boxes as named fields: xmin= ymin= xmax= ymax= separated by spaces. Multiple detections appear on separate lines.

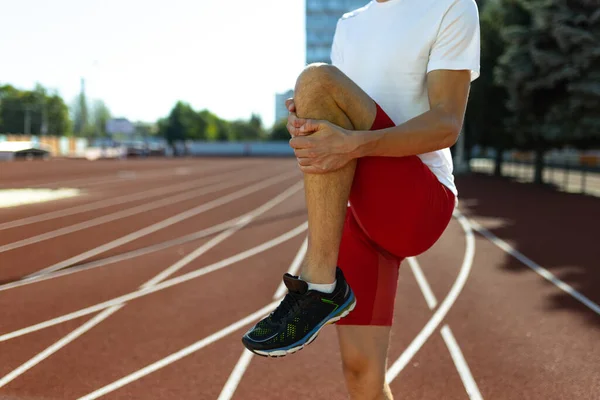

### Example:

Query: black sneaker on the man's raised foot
xmin=242 ymin=268 xmax=356 ymax=357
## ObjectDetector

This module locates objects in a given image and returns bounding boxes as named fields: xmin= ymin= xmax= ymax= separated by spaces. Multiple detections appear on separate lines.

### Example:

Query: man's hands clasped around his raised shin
xmin=285 ymin=99 xmax=354 ymax=174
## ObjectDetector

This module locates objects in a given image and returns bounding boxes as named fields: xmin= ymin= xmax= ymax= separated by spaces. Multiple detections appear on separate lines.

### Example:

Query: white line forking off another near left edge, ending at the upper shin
xmin=28 ymin=171 xmax=297 ymax=277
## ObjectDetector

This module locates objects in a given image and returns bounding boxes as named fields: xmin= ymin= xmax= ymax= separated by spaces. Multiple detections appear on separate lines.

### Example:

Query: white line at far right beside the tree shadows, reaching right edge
xmin=469 ymin=220 xmax=600 ymax=315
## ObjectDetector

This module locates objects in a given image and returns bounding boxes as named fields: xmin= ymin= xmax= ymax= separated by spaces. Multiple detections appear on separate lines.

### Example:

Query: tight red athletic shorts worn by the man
xmin=338 ymin=105 xmax=455 ymax=326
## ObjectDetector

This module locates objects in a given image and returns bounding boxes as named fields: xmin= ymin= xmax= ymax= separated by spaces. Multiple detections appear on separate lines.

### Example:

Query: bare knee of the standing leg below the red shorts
xmin=342 ymin=355 xmax=391 ymax=400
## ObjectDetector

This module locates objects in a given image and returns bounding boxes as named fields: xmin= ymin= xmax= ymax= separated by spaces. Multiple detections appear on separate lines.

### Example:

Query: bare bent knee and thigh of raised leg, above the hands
xmin=294 ymin=63 xmax=377 ymax=130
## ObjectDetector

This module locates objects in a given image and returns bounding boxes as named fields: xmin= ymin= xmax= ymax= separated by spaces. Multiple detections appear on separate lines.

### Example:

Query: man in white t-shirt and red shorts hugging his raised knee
xmin=242 ymin=0 xmax=480 ymax=399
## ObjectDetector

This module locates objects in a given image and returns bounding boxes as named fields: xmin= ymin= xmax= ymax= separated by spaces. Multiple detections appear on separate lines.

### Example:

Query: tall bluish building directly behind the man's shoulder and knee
xmin=306 ymin=0 xmax=369 ymax=64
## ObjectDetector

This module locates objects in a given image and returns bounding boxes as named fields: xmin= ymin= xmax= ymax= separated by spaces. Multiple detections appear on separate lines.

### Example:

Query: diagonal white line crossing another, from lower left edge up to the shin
xmin=0 ymin=181 xmax=303 ymax=387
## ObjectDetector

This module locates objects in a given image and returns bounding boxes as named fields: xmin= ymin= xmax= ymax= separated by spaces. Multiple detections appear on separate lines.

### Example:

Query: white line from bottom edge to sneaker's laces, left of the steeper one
xmin=78 ymin=301 xmax=278 ymax=400
